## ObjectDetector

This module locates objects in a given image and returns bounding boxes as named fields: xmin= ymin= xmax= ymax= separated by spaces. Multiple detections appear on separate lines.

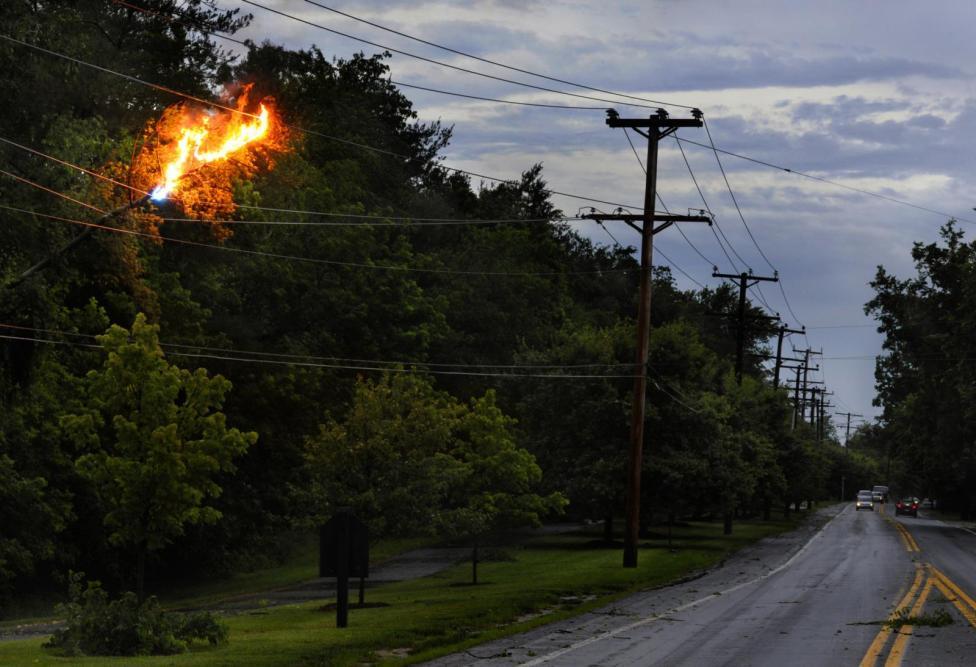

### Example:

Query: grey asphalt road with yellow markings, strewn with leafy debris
xmin=430 ymin=504 xmax=976 ymax=667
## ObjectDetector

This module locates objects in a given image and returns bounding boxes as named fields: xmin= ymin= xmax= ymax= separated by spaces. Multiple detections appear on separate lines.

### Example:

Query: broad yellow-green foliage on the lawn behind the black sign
xmin=306 ymin=373 xmax=565 ymax=580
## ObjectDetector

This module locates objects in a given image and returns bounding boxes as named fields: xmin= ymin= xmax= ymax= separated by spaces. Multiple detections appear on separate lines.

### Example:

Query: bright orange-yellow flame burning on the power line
xmin=150 ymin=89 xmax=272 ymax=201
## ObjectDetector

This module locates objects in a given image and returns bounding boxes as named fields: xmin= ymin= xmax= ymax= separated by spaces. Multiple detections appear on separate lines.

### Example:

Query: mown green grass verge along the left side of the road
xmin=0 ymin=521 xmax=795 ymax=666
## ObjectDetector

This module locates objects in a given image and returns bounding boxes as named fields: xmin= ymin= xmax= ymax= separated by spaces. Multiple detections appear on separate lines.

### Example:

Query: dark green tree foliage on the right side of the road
xmin=865 ymin=221 xmax=976 ymax=516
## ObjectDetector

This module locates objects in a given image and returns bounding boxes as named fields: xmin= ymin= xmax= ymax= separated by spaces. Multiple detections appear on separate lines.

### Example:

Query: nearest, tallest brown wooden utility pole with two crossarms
xmin=583 ymin=109 xmax=712 ymax=567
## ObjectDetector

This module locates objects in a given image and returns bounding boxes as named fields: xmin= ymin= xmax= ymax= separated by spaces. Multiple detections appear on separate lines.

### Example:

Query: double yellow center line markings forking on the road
xmin=861 ymin=517 xmax=976 ymax=667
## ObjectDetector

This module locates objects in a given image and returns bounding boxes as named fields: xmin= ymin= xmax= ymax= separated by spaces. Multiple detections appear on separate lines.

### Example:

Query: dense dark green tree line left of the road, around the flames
xmin=0 ymin=0 xmax=852 ymax=612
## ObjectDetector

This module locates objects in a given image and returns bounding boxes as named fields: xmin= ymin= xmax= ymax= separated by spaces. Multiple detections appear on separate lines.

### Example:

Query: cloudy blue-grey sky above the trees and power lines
xmin=225 ymin=0 xmax=976 ymax=423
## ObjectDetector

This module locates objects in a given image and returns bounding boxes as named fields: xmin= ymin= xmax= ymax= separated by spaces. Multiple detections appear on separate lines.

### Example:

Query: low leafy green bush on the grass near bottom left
xmin=44 ymin=572 xmax=227 ymax=656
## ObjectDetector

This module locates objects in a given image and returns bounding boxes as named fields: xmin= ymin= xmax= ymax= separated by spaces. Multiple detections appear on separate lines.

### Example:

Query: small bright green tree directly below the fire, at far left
xmin=61 ymin=314 xmax=257 ymax=598
